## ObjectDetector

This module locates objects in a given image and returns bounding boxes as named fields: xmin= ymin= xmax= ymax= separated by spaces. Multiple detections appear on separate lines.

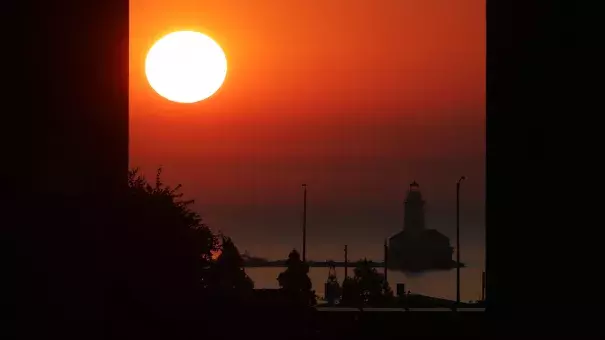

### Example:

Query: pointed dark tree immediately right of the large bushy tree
xmin=212 ymin=236 xmax=254 ymax=298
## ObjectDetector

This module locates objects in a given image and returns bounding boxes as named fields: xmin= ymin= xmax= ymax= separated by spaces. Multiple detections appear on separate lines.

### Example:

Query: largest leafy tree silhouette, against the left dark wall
xmin=126 ymin=168 xmax=218 ymax=313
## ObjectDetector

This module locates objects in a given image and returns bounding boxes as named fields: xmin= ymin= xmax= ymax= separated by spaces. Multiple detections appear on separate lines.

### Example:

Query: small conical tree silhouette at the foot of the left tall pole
xmin=277 ymin=250 xmax=316 ymax=305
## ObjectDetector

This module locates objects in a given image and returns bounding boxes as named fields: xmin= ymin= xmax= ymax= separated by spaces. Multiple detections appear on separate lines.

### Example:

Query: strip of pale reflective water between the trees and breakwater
xmin=246 ymin=267 xmax=483 ymax=301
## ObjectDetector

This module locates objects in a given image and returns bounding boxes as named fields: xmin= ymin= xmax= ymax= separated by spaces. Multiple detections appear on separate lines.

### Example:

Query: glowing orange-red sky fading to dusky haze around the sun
xmin=130 ymin=0 xmax=485 ymax=258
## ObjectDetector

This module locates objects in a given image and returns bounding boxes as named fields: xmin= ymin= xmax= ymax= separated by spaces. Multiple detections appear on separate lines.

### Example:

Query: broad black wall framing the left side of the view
xmin=1 ymin=0 xmax=129 ymax=330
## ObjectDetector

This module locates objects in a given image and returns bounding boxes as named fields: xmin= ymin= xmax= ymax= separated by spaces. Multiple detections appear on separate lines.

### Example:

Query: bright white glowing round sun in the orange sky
xmin=145 ymin=31 xmax=227 ymax=103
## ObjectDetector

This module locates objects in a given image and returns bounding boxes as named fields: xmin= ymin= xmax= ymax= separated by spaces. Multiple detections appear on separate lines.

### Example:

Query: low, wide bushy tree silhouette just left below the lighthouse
xmin=342 ymin=259 xmax=393 ymax=306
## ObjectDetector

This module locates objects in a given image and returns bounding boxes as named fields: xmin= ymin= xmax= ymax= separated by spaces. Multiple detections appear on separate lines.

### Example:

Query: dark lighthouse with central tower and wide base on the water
xmin=388 ymin=181 xmax=455 ymax=271
